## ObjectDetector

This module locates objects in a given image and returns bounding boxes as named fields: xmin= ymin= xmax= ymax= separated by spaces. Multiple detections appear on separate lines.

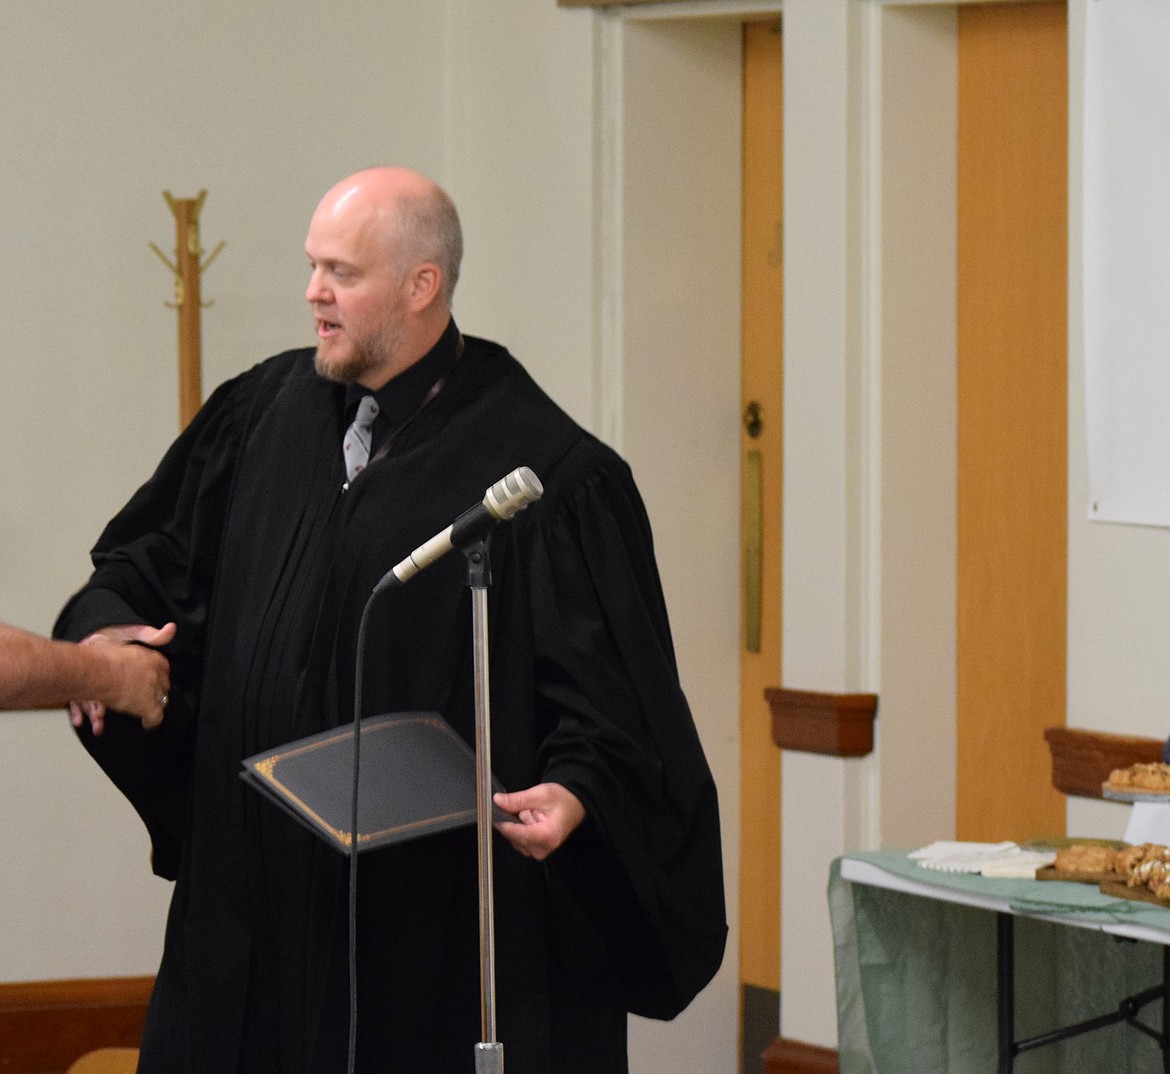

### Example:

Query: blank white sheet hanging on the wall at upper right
xmin=1083 ymin=0 xmax=1170 ymax=526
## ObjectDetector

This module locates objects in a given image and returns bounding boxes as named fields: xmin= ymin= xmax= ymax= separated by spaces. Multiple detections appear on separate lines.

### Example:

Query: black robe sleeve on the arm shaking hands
xmin=54 ymin=370 xmax=257 ymax=879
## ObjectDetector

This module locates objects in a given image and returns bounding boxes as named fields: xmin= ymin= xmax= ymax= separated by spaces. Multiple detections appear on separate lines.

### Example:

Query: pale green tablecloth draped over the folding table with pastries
xmin=828 ymin=851 xmax=1170 ymax=1074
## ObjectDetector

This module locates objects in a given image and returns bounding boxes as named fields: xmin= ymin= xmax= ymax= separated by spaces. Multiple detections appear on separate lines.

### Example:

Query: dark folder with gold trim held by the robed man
xmin=240 ymin=712 xmax=507 ymax=853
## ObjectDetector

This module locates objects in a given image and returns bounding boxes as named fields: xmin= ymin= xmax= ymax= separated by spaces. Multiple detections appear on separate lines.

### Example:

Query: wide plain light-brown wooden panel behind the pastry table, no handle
xmin=957 ymin=4 xmax=1068 ymax=840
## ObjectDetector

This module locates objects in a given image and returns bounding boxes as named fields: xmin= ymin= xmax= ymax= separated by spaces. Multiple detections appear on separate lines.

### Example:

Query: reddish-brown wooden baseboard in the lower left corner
xmin=0 ymin=977 xmax=154 ymax=1074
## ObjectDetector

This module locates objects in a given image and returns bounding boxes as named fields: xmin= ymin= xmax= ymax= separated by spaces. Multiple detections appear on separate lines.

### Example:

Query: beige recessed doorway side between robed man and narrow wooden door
xmin=599 ymin=19 xmax=742 ymax=1072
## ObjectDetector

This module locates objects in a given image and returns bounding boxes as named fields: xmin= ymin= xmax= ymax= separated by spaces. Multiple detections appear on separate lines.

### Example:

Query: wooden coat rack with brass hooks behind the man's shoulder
xmin=150 ymin=191 xmax=225 ymax=429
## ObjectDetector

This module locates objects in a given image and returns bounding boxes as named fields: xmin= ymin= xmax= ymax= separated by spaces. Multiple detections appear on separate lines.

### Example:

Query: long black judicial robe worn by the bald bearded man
xmin=57 ymin=337 xmax=727 ymax=1074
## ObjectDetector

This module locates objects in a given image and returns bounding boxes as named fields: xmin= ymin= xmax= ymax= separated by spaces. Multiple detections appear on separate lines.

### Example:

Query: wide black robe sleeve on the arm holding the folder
xmin=527 ymin=456 xmax=727 ymax=1018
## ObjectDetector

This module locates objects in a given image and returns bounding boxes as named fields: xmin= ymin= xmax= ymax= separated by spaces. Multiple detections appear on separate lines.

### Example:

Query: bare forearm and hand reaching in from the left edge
xmin=0 ymin=624 xmax=174 ymax=727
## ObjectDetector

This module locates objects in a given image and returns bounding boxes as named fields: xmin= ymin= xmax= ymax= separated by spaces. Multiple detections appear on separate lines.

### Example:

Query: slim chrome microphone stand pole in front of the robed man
xmin=463 ymin=542 xmax=504 ymax=1074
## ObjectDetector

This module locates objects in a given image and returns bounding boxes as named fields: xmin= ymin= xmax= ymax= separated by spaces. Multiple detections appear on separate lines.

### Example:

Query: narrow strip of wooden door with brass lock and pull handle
xmin=739 ymin=20 xmax=784 ymax=1072
